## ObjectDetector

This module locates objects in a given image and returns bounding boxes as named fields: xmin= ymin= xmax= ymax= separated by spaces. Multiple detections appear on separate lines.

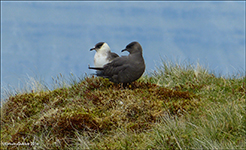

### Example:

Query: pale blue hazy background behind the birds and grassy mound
xmin=1 ymin=1 xmax=245 ymax=96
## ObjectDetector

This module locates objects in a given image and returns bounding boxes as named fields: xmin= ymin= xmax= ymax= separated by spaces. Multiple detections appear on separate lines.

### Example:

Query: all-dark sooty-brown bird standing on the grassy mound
xmin=89 ymin=41 xmax=145 ymax=84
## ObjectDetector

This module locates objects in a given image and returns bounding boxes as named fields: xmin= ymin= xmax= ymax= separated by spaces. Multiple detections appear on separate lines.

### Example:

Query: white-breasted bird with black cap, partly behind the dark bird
xmin=90 ymin=42 xmax=119 ymax=67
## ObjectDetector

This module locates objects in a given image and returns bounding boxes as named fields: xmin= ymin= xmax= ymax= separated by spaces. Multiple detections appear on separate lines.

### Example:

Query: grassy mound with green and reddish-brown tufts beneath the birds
xmin=1 ymin=63 xmax=246 ymax=149
